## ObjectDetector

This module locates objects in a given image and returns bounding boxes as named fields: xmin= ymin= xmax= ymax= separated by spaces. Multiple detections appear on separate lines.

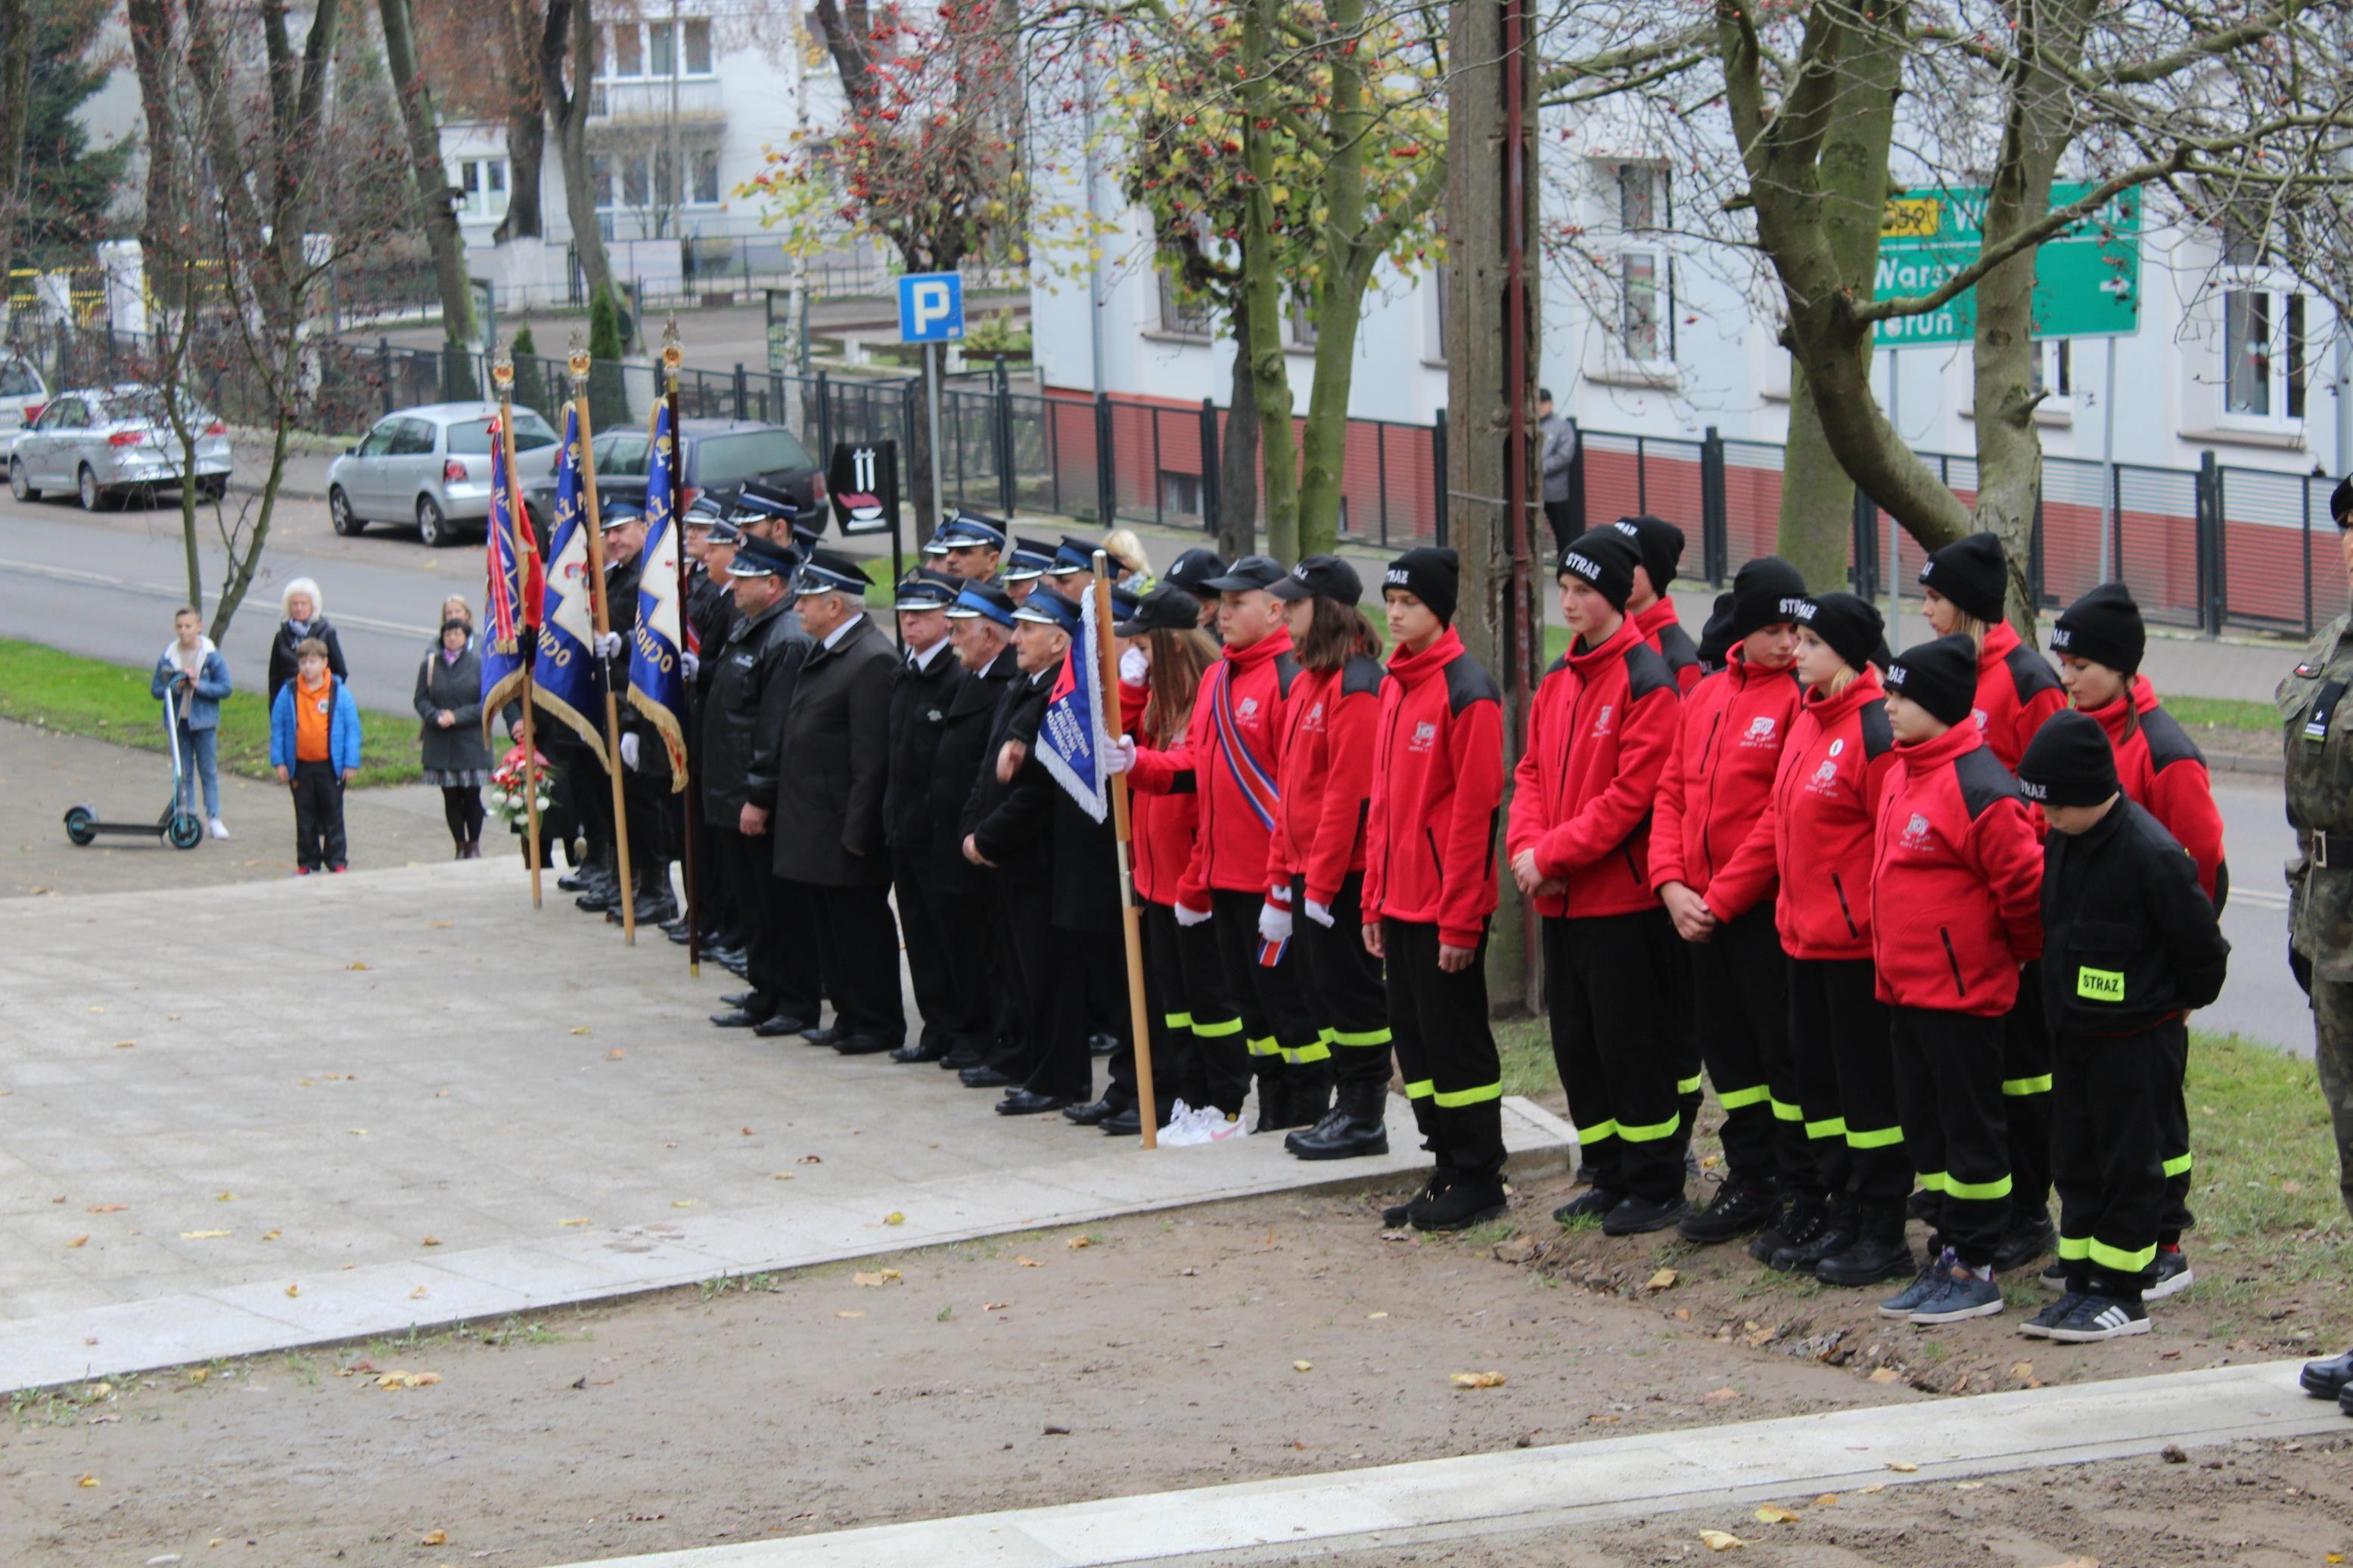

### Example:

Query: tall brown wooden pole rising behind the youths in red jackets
xmin=1445 ymin=0 xmax=1543 ymax=1004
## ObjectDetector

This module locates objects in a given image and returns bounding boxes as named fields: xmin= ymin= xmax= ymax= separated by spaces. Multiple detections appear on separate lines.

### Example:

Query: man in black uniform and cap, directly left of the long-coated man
xmin=701 ymin=539 xmax=819 ymax=1037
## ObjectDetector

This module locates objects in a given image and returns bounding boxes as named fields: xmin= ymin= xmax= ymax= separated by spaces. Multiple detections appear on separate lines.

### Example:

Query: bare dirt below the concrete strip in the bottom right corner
xmin=1334 ymin=1422 xmax=2353 ymax=1568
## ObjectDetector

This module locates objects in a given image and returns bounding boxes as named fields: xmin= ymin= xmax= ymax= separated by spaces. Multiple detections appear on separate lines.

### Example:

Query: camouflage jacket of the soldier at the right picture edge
xmin=2277 ymin=616 xmax=2353 ymax=980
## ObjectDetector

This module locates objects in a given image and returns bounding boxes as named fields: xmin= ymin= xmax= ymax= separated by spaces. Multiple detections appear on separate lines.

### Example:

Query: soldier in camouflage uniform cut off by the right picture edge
xmin=2280 ymin=480 xmax=2353 ymax=1415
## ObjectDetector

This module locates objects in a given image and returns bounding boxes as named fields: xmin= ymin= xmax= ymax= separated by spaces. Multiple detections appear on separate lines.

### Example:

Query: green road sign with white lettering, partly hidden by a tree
xmin=1873 ymin=183 xmax=2141 ymax=348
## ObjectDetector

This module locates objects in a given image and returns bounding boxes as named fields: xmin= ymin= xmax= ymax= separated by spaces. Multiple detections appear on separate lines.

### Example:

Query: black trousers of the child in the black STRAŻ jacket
xmin=2052 ymin=1018 xmax=2188 ymax=1300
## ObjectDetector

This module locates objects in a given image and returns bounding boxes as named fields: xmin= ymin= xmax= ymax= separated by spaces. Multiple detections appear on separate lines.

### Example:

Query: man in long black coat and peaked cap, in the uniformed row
xmin=774 ymin=550 xmax=906 ymax=1055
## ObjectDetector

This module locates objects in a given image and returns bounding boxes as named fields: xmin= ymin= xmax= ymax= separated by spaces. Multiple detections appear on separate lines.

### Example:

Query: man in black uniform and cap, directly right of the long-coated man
xmin=882 ymin=569 xmax=965 ymax=1063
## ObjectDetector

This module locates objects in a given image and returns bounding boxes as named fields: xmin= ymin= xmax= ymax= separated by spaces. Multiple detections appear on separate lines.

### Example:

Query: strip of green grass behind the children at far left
xmin=0 ymin=639 xmax=424 ymax=787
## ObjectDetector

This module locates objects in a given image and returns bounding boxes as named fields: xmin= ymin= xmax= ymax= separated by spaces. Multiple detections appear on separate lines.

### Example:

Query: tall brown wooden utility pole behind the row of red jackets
xmin=1445 ymin=0 xmax=1550 ymax=1006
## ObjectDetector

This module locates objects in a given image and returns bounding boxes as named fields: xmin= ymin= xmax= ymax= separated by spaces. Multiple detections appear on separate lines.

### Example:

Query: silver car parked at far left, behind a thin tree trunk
xmin=7 ymin=380 xmax=231 ymax=513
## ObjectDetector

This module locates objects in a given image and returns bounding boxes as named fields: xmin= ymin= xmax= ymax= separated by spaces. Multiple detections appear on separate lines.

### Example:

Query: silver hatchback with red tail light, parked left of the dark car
xmin=327 ymin=402 xmax=555 ymax=545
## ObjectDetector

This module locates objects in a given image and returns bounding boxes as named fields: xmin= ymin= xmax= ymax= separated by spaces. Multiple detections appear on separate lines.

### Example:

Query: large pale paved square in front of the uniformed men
xmin=0 ymin=861 xmax=1574 ymax=1389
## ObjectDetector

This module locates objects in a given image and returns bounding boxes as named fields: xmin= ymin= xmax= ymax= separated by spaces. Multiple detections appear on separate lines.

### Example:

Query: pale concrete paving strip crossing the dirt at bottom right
xmin=546 ymin=1362 xmax=2344 ymax=1568
